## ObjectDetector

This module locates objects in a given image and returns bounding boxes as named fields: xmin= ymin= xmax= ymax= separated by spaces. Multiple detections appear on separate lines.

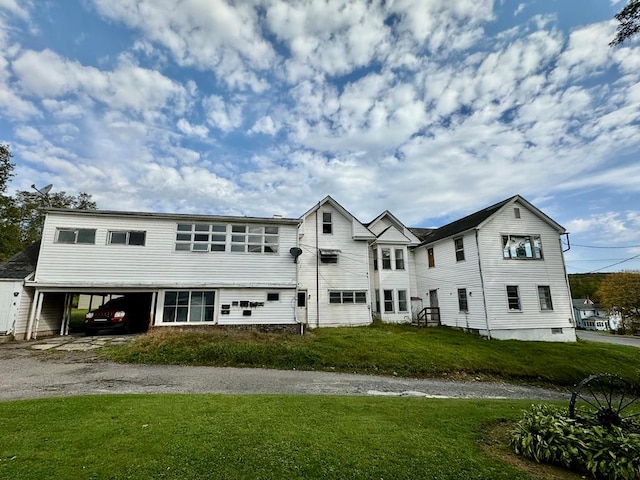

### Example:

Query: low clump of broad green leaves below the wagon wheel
xmin=510 ymin=405 xmax=640 ymax=480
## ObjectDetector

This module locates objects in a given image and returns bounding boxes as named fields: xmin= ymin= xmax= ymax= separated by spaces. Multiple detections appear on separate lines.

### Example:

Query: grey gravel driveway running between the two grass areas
xmin=0 ymin=340 xmax=570 ymax=401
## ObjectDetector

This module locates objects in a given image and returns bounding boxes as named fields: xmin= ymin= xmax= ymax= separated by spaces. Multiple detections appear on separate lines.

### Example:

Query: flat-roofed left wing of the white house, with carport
xmin=15 ymin=209 xmax=299 ymax=339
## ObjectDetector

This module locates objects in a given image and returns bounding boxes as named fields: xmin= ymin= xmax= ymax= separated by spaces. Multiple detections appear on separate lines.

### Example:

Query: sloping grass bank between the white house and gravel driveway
xmin=104 ymin=324 xmax=640 ymax=387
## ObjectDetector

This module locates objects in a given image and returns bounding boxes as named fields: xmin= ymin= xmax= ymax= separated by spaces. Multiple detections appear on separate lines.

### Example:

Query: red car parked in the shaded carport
xmin=84 ymin=294 xmax=151 ymax=335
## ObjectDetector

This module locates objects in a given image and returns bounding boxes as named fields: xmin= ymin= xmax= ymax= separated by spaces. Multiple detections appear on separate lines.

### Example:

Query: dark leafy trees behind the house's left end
xmin=0 ymin=143 xmax=96 ymax=262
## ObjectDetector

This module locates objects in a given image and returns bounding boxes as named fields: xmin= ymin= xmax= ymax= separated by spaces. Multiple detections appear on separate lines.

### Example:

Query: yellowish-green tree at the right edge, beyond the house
xmin=598 ymin=272 xmax=640 ymax=333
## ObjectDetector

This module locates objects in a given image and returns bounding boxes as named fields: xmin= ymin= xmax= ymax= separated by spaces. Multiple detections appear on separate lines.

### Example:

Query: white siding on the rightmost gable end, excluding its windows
xmin=479 ymin=204 xmax=573 ymax=339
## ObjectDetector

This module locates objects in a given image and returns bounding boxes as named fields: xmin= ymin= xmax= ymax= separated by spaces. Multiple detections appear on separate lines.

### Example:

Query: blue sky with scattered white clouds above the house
xmin=0 ymin=0 xmax=640 ymax=273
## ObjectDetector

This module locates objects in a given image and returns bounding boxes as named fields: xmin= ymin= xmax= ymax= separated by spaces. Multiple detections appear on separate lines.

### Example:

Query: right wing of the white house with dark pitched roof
xmin=414 ymin=195 xmax=576 ymax=341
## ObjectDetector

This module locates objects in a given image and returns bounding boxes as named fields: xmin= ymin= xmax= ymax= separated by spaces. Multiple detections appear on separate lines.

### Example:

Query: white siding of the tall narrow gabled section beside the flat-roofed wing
xmin=298 ymin=203 xmax=371 ymax=327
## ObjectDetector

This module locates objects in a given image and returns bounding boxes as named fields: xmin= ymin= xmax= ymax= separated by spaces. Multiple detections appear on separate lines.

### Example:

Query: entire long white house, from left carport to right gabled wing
xmin=0 ymin=195 xmax=575 ymax=341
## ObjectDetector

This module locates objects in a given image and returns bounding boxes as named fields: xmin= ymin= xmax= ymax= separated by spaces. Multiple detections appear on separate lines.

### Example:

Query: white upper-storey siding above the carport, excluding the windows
xmin=35 ymin=212 xmax=296 ymax=287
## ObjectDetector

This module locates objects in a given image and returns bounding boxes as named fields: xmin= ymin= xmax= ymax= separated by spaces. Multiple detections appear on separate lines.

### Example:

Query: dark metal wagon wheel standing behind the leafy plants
xmin=569 ymin=373 xmax=640 ymax=430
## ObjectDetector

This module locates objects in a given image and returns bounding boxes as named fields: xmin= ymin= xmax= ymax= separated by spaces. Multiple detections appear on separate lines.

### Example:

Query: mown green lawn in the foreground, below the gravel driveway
xmin=0 ymin=395 xmax=580 ymax=480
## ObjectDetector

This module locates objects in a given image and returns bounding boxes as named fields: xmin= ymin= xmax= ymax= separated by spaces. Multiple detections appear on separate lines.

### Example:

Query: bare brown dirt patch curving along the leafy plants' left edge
xmin=478 ymin=420 xmax=592 ymax=480
